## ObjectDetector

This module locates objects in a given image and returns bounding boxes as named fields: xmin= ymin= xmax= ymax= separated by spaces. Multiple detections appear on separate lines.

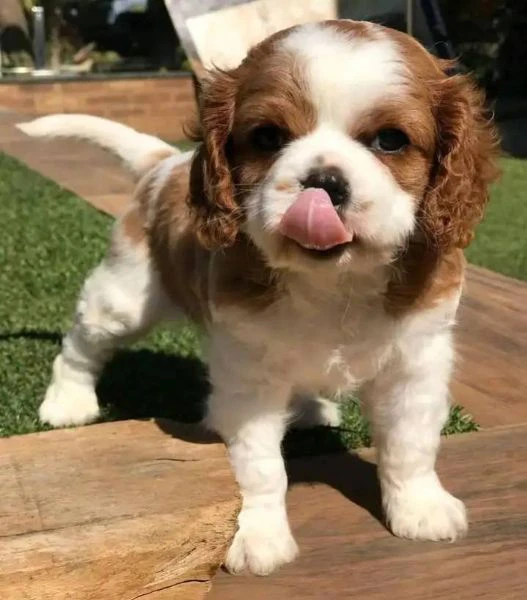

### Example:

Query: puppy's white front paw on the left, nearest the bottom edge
xmin=225 ymin=508 xmax=298 ymax=575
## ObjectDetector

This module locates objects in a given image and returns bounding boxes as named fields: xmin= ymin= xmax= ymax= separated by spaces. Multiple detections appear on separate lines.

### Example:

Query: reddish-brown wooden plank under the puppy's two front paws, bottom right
xmin=208 ymin=425 xmax=527 ymax=600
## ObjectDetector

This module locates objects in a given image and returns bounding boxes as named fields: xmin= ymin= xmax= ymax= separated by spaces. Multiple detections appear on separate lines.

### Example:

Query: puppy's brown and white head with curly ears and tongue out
xmin=190 ymin=21 xmax=496 ymax=271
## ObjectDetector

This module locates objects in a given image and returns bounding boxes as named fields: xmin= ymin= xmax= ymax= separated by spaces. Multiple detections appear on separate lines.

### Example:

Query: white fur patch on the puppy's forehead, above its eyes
xmin=282 ymin=24 xmax=407 ymax=128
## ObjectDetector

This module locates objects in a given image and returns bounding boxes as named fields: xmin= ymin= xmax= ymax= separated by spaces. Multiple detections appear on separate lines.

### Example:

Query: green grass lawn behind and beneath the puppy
xmin=0 ymin=154 xmax=527 ymax=454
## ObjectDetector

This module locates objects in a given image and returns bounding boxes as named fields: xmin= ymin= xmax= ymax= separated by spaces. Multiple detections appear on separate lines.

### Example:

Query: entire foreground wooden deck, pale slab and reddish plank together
xmin=0 ymin=421 xmax=527 ymax=600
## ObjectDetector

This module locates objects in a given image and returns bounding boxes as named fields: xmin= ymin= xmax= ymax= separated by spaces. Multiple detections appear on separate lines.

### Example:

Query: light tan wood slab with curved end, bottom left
xmin=0 ymin=421 xmax=239 ymax=600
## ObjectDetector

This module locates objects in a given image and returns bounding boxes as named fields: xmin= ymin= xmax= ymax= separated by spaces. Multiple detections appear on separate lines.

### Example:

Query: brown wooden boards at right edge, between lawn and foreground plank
xmin=452 ymin=266 xmax=527 ymax=427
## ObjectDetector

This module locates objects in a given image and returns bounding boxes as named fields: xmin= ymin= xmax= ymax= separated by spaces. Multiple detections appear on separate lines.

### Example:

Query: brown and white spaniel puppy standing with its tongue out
xmin=20 ymin=20 xmax=497 ymax=575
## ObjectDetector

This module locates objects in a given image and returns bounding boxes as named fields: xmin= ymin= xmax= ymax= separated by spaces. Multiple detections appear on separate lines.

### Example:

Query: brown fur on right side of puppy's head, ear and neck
xmin=376 ymin=24 xmax=498 ymax=315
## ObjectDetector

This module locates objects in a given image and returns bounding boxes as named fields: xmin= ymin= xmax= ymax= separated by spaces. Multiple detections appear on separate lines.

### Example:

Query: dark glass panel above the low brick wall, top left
xmin=0 ymin=0 xmax=188 ymax=75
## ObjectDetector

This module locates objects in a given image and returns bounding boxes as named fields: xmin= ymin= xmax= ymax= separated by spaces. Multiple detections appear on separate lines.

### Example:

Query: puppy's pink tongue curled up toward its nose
xmin=280 ymin=188 xmax=353 ymax=250
